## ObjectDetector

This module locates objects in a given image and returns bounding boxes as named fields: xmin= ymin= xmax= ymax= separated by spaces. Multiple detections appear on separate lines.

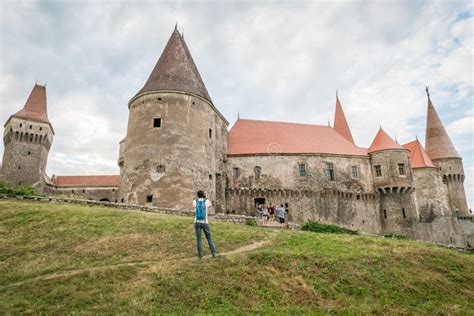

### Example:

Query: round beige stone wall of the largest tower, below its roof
xmin=119 ymin=92 xmax=227 ymax=210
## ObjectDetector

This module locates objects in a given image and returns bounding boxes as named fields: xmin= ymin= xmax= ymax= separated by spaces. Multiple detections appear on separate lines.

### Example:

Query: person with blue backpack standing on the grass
xmin=193 ymin=191 xmax=216 ymax=258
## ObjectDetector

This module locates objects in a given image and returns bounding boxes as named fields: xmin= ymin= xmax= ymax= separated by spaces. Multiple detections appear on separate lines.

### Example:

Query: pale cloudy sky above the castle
xmin=0 ymin=0 xmax=474 ymax=207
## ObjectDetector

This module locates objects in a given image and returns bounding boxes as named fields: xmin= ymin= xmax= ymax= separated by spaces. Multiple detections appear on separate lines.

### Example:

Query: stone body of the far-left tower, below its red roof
xmin=2 ymin=117 xmax=53 ymax=188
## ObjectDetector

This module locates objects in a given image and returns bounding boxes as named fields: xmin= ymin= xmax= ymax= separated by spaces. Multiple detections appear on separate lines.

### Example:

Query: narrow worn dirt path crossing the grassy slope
xmin=0 ymin=240 xmax=271 ymax=289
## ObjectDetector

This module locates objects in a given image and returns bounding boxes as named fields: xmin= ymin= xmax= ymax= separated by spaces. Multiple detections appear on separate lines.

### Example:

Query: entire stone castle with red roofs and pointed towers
xmin=2 ymin=29 xmax=474 ymax=248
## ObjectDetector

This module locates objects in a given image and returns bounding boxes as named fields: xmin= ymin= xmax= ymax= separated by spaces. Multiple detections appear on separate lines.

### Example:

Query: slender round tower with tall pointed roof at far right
xmin=425 ymin=88 xmax=469 ymax=214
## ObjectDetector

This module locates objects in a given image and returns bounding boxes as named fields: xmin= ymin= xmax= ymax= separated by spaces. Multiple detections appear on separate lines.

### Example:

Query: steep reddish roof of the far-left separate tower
xmin=12 ymin=84 xmax=50 ymax=124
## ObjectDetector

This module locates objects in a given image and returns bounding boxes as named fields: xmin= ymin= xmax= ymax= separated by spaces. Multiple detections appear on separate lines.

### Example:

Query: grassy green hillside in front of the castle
xmin=0 ymin=201 xmax=474 ymax=314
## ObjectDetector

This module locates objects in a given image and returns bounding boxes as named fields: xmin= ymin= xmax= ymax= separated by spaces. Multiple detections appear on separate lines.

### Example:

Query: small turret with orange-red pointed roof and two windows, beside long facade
xmin=368 ymin=128 xmax=417 ymax=234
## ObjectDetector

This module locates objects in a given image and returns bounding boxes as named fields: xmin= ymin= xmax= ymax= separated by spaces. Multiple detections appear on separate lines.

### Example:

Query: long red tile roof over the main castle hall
xmin=228 ymin=119 xmax=367 ymax=156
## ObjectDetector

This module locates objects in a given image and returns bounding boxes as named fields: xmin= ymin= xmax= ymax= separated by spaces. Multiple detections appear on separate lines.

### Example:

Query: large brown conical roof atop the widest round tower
xmin=136 ymin=28 xmax=212 ymax=103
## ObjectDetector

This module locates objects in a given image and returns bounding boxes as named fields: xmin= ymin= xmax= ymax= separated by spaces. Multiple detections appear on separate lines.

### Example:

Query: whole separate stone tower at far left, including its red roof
xmin=2 ymin=84 xmax=54 ymax=188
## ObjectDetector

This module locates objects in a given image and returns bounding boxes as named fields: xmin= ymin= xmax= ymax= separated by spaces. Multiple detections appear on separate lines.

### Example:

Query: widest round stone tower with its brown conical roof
xmin=118 ymin=28 xmax=228 ymax=211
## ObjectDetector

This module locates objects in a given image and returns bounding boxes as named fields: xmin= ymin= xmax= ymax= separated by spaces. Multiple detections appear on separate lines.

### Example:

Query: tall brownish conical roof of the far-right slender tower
xmin=425 ymin=96 xmax=461 ymax=160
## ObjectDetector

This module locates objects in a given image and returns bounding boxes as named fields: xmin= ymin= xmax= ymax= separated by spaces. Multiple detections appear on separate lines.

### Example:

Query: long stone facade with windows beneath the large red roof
xmin=226 ymin=155 xmax=380 ymax=233
